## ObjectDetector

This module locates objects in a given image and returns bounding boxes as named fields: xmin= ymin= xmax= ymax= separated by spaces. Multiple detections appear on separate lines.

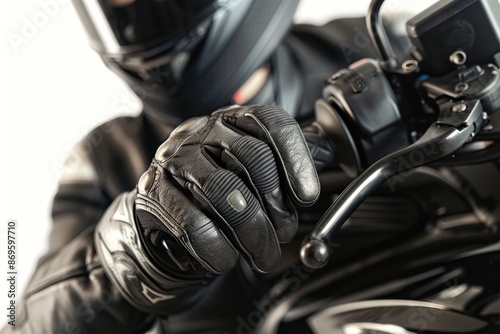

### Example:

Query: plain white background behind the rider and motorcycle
xmin=0 ymin=0 xmax=434 ymax=327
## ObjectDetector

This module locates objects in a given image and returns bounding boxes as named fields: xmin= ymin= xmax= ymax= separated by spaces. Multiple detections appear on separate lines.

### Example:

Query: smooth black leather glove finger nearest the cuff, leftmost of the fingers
xmin=136 ymin=166 xmax=238 ymax=274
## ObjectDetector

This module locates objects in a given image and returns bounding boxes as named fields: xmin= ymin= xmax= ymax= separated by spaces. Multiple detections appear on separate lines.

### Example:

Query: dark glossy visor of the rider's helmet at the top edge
xmin=75 ymin=0 xmax=221 ymax=55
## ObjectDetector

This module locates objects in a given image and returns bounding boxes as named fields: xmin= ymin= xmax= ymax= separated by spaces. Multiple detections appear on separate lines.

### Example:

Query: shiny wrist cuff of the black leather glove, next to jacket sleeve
xmin=95 ymin=192 xmax=207 ymax=316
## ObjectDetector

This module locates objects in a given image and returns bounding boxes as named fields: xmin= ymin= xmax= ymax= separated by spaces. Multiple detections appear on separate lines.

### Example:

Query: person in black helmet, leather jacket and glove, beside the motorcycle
xmin=3 ymin=0 xmax=382 ymax=333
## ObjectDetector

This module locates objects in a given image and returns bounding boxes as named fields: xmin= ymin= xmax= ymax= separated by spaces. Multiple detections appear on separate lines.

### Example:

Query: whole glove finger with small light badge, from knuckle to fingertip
xmin=162 ymin=152 xmax=281 ymax=272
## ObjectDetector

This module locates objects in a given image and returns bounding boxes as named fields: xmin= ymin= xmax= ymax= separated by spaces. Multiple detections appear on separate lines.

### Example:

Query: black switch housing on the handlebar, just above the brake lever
xmin=323 ymin=58 xmax=409 ymax=167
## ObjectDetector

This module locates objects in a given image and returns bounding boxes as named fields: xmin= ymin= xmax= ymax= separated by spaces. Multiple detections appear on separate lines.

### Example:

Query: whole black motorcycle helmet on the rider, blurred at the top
xmin=73 ymin=0 xmax=298 ymax=124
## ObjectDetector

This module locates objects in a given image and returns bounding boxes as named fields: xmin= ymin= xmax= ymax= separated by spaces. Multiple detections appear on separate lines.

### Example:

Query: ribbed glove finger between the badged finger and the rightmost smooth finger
xmin=225 ymin=136 xmax=298 ymax=243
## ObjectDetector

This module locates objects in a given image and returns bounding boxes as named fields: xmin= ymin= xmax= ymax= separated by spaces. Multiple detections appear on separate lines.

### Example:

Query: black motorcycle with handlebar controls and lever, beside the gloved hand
xmin=250 ymin=0 xmax=500 ymax=334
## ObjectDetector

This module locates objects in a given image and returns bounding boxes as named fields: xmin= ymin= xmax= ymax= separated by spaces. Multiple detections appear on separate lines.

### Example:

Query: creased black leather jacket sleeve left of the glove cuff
xmin=1 ymin=142 xmax=150 ymax=334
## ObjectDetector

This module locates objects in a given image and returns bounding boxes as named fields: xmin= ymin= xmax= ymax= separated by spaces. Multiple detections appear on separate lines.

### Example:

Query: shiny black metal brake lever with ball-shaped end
xmin=300 ymin=99 xmax=487 ymax=269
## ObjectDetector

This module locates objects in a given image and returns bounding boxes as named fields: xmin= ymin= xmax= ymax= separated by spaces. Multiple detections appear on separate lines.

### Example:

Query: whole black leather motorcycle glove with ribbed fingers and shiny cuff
xmin=96 ymin=106 xmax=320 ymax=315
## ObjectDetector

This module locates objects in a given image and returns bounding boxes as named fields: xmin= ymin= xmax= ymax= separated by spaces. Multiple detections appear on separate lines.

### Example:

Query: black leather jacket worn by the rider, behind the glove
xmin=2 ymin=19 xmax=382 ymax=334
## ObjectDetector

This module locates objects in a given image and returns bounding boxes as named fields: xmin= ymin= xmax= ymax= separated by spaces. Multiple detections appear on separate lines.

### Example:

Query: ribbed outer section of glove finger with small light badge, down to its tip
xmin=190 ymin=168 xmax=281 ymax=272
